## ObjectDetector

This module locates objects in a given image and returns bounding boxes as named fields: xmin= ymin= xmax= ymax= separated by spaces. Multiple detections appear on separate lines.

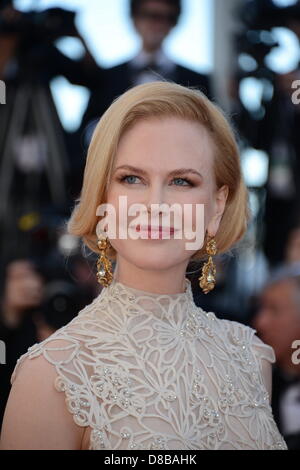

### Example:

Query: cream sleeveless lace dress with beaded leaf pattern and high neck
xmin=11 ymin=279 xmax=287 ymax=450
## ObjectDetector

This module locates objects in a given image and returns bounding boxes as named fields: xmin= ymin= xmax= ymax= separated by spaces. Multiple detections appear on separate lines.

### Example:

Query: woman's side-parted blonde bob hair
xmin=68 ymin=80 xmax=250 ymax=260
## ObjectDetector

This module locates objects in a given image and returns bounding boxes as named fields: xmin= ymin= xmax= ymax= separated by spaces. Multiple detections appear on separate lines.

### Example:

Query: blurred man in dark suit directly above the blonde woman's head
xmin=81 ymin=0 xmax=213 ymax=146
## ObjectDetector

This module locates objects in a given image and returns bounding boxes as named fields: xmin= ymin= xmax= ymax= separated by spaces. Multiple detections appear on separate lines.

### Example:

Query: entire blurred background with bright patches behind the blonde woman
xmin=0 ymin=0 xmax=300 ymax=449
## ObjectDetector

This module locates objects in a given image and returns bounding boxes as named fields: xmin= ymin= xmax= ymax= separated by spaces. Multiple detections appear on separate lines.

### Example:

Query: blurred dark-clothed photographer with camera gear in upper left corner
xmin=0 ymin=2 xmax=102 ymax=250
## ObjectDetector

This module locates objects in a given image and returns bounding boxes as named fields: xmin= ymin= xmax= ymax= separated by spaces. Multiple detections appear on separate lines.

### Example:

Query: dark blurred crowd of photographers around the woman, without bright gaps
xmin=0 ymin=0 xmax=300 ymax=450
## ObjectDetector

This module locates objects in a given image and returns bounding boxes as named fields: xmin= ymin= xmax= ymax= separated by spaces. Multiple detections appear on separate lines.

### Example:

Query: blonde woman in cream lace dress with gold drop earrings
xmin=1 ymin=81 xmax=286 ymax=450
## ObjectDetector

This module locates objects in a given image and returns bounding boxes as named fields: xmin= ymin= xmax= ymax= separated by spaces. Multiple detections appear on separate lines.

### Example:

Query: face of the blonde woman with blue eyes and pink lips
xmin=107 ymin=117 xmax=227 ymax=270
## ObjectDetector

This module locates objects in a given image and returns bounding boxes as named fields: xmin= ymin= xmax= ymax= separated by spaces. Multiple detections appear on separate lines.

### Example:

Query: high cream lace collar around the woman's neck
xmin=99 ymin=278 xmax=196 ymax=321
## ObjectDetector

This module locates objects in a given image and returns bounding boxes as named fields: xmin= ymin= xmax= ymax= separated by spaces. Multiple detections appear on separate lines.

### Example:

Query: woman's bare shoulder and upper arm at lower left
xmin=0 ymin=340 xmax=84 ymax=450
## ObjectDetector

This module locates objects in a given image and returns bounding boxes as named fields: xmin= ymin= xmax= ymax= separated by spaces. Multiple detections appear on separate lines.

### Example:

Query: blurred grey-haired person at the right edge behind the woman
xmin=252 ymin=262 xmax=300 ymax=450
